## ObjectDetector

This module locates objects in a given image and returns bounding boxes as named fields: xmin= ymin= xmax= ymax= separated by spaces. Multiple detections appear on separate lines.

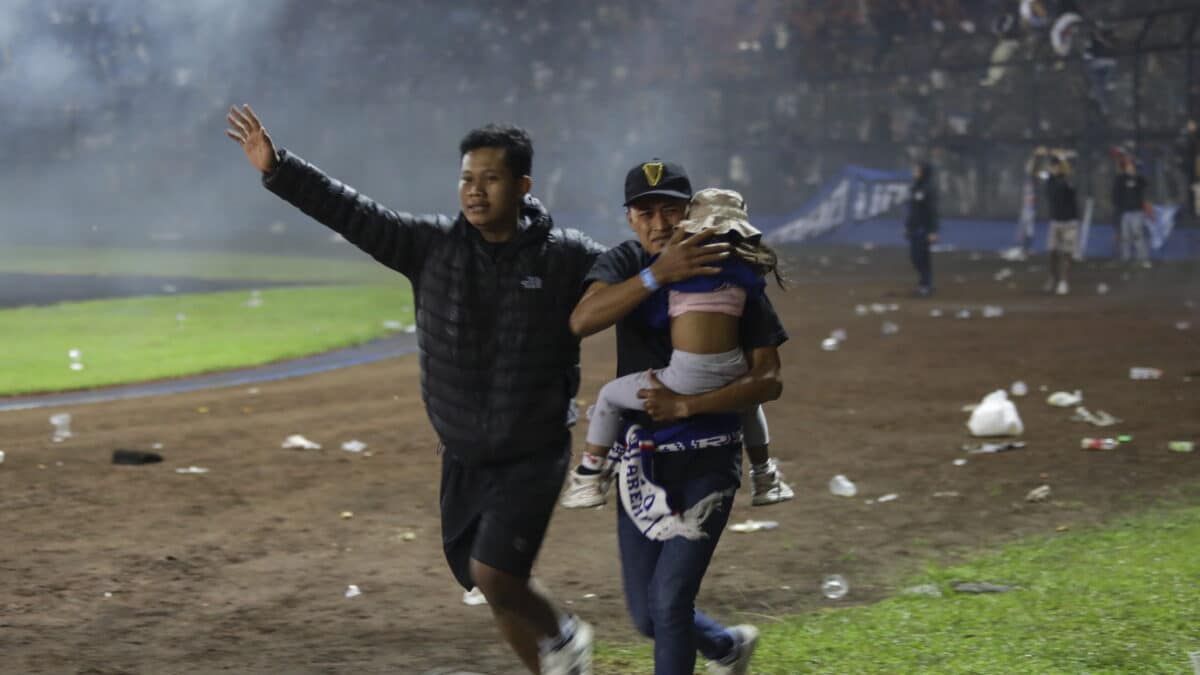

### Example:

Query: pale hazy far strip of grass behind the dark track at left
xmin=0 ymin=246 xmax=397 ymax=283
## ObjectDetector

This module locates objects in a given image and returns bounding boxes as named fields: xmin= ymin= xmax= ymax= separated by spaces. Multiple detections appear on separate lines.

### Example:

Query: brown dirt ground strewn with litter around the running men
xmin=0 ymin=249 xmax=1200 ymax=674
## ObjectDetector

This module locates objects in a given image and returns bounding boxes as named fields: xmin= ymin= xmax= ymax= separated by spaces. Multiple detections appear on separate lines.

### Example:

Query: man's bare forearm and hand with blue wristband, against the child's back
xmin=570 ymin=228 xmax=730 ymax=338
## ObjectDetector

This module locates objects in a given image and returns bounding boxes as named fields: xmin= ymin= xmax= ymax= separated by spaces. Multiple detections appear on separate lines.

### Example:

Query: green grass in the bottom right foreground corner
xmin=596 ymin=495 xmax=1200 ymax=675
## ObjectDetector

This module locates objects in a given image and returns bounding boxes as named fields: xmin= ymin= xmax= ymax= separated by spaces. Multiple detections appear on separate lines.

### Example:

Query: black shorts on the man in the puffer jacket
xmin=442 ymin=437 xmax=571 ymax=590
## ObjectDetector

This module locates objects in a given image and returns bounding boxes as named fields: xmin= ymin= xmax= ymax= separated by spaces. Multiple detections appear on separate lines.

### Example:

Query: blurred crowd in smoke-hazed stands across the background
xmin=0 ymin=0 xmax=1200 ymax=241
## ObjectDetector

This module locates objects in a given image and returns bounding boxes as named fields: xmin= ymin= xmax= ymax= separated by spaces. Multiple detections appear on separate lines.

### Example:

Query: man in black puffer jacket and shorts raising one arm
xmin=227 ymin=106 xmax=602 ymax=673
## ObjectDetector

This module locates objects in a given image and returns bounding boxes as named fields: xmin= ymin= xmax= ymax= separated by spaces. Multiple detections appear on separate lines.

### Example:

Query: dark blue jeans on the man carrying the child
xmin=616 ymin=448 xmax=736 ymax=675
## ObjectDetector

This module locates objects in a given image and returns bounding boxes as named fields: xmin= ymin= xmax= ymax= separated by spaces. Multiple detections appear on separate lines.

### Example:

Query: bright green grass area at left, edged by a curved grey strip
xmin=0 ymin=283 xmax=413 ymax=395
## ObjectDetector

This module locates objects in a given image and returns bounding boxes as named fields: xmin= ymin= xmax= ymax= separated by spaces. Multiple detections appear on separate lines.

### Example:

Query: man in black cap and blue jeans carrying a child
xmin=570 ymin=160 xmax=787 ymax=673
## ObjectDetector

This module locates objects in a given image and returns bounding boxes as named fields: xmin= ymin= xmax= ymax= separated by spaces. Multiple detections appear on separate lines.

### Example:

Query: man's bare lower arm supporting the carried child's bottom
xmin=637 ymin=347 xmax=784 ymax=422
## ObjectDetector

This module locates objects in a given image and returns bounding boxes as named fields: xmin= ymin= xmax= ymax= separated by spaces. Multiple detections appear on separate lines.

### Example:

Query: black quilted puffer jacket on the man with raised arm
xmin=263 ymin=150 xmax=604 ymax=465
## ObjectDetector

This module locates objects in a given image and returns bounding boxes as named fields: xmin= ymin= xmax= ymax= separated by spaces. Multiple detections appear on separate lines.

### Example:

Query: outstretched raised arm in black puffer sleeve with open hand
xmin=226 ymin=106 xmax=441 ymax=277
